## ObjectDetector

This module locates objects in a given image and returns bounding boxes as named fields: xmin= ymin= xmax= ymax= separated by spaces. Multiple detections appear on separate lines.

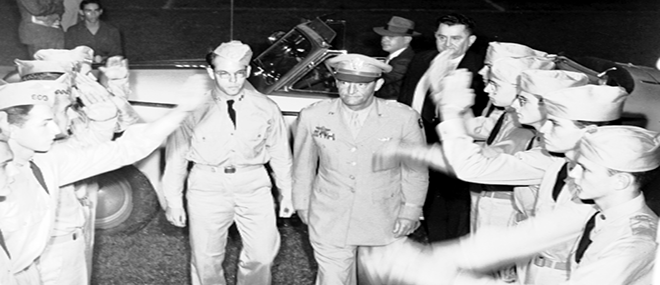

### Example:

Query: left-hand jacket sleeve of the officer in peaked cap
xmin=292 ymin=110 xmax=319 ymax=210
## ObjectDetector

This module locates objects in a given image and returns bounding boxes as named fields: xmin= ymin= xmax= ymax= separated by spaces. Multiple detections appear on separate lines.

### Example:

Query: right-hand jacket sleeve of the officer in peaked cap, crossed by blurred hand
xmin=399 ymin=113 xmax=429 ymax=221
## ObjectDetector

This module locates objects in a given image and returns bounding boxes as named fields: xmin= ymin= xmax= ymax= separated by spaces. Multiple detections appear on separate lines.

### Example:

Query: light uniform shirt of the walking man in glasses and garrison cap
xmin=163 ymin=88 xmax=291 ymax=208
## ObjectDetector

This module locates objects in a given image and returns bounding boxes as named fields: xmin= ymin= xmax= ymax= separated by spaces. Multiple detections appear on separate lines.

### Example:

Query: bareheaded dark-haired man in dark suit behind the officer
xmin=397 ymin=14 xmax=488 ymax=241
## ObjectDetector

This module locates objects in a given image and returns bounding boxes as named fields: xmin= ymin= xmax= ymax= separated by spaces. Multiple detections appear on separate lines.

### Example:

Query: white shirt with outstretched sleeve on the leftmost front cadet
xmin=0 ymin=125 xmax=162 ymax=278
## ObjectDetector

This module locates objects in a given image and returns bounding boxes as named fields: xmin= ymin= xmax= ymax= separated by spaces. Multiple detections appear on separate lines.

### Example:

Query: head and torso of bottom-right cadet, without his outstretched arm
xmin=556 ymin=126 xmax=660 ymax=284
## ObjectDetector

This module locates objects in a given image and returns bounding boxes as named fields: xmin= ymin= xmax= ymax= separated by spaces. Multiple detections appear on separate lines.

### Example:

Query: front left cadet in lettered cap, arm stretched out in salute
xmin=0 ymin=76 xmax=204 ymax=284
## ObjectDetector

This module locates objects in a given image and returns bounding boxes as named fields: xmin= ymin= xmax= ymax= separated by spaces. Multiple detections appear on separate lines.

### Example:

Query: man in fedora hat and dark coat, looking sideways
xmin=374 ymin=16 xmax=421 ymax=99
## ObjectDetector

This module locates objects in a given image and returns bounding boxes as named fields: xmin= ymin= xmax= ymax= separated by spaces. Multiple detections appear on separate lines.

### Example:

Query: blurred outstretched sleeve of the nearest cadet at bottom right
xmin=455 ymin=202 xmax=598 ymax=270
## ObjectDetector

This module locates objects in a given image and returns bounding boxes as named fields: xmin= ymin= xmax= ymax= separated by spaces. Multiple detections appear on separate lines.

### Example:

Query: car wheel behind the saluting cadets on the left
xmin=95 ymin=165 xmax=158 ymax=234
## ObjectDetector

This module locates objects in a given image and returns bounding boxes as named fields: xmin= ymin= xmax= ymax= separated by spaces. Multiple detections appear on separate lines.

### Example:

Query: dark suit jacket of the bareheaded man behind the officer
xmin=397 ymin=44 xmax=489 ymax=143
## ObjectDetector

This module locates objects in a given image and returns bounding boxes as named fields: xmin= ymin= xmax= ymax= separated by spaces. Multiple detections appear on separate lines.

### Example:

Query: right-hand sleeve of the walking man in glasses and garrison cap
xmin=266 ymin=106 xmax=292 ymax=200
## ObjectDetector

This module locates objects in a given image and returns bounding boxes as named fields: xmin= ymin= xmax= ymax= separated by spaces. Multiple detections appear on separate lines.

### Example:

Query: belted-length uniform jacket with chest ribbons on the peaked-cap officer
xmin=293 ymin=98 xmax=428 ymax=246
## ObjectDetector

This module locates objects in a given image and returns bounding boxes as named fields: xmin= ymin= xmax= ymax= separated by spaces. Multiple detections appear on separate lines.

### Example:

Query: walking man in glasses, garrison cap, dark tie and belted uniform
xmin=163 ymin=41 xmax=293 ymax=284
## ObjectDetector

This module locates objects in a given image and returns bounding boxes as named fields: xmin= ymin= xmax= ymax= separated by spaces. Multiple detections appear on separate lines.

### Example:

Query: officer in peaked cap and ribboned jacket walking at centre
xmin=293 ymin=54 xmax=428 ymax=284
